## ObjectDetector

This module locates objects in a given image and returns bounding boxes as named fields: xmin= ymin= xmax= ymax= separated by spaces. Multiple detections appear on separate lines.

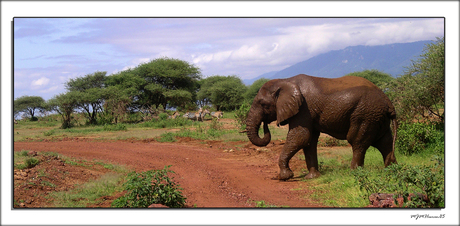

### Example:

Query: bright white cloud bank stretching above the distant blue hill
xmin=190 ymin=18 xmax=444 ymax=76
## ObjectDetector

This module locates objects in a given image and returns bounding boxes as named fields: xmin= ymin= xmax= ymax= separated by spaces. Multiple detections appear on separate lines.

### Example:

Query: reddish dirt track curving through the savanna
xmin=14 ymin=139 xmax=321 ymax=208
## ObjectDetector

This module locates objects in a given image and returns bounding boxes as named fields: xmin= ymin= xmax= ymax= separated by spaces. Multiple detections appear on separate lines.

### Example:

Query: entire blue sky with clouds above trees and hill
xmin=14 ymin=18 xmax=444 ymax=100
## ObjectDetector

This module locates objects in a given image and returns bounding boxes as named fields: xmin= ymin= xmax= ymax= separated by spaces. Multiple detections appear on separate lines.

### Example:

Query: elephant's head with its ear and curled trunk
xmin=245 ymin=79 xmax=304 ymax=147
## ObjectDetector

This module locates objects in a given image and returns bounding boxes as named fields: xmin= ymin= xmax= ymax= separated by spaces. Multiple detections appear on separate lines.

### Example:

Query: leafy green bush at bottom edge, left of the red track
xmin=112 ymin=166 xmax=186 ymax=208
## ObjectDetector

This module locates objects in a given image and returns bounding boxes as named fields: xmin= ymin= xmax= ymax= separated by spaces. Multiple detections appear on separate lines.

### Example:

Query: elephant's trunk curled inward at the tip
xmin=246 ymin=110 xmax=271 ymax=147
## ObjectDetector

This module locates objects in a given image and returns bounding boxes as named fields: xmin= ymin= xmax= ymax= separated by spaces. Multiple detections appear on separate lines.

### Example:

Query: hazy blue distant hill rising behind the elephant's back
xmin=243 ymin=41 xmax=432 ymax=84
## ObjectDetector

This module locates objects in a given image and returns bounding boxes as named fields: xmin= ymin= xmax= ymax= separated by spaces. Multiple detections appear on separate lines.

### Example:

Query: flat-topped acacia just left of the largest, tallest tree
xmin=65 ymin=71 xmax=107 ymax=124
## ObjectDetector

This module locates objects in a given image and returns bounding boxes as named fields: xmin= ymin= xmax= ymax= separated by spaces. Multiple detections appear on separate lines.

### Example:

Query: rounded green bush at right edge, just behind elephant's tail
xmin=396 ymin=123 xmax=444 ymax=155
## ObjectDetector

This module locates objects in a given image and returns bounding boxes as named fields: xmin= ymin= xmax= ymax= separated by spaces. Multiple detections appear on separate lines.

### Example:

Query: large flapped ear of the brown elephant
xmin=274 ymin=82 xmax=303 ymax=126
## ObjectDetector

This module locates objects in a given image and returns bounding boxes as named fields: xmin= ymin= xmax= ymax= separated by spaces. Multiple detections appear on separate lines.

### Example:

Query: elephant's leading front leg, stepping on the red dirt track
xmin=278 ymin=126 xmax=310 ymax=180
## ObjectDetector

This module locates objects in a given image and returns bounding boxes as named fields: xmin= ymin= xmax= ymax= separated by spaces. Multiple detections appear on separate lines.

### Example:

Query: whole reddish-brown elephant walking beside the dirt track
xmin=245 ymin=74 xmax=397 ymax=180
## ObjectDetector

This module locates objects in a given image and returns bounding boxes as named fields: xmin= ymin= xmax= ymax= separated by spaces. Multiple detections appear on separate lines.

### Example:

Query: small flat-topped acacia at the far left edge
xmin=13 ymin=96 xmax=45 ymax=121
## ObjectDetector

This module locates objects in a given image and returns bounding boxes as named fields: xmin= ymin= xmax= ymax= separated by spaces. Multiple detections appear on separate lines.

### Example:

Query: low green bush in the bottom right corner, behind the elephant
xmin=352 ymin=156 xmax=445 ymax=208
